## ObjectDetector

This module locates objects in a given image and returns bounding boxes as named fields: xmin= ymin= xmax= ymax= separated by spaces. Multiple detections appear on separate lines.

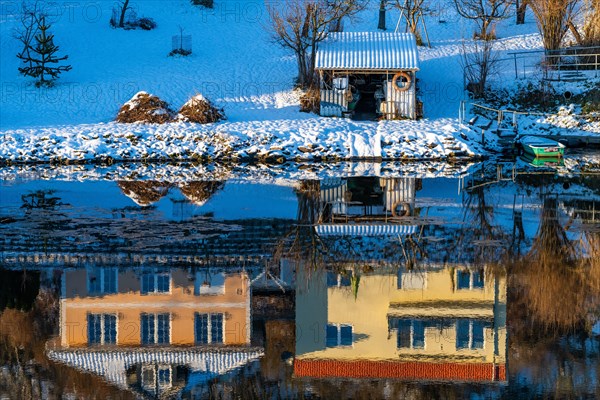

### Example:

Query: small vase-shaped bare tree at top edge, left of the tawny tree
xmin=454 ymin=0 xmax=514 ymax=40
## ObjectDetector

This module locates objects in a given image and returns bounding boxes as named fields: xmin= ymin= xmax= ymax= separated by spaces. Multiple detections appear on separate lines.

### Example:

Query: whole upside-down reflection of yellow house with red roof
xmin=294 ymin=267 xmax=506 ymax=381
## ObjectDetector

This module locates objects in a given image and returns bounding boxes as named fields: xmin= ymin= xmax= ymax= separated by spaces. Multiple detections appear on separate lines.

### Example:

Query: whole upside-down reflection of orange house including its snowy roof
xmin=48 ymin=268 xmax=263 ymax=397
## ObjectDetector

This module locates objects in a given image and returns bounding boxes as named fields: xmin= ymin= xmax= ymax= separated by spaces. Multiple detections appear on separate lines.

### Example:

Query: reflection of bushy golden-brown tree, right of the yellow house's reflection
xmin=511 ymin=196 xmax=600 ymax=337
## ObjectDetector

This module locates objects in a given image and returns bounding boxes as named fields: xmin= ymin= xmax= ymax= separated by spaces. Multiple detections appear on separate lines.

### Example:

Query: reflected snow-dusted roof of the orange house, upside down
xmin=48 ymin=347 xmax=264 ymax=388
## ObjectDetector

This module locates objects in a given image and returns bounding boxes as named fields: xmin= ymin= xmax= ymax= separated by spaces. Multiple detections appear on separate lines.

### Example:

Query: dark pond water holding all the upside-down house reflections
xmin=0 ymin=166 xmax=600 ymax=399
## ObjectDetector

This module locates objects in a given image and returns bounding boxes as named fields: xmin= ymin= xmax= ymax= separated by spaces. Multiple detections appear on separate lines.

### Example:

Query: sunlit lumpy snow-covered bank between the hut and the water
xmin=0 ymin=117 xmax=485 ymax=162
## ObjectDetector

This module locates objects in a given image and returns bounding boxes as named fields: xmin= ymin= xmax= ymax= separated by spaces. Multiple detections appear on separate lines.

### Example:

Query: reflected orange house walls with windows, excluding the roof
xmin=60 ymin=268 xmax=250 ymax=347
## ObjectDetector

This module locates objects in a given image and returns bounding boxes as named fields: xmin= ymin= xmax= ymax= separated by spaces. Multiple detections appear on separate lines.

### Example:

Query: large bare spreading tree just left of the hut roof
xmin=268 ymin=0 xmax=367 ymax=88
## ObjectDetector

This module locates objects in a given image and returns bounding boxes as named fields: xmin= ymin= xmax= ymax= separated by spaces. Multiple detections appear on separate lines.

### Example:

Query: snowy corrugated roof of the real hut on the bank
xmin=315 ymin=32 xmax=419 ymax=70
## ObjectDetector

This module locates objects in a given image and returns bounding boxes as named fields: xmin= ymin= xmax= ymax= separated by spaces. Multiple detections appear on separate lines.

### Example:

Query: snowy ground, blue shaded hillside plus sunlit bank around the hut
xmin=0 ymin=0 xmax=600 ymax=162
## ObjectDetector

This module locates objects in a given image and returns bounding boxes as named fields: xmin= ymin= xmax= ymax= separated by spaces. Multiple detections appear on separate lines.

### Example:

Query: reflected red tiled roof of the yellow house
xmin=294 ymin=359 xmax=506 ymax=382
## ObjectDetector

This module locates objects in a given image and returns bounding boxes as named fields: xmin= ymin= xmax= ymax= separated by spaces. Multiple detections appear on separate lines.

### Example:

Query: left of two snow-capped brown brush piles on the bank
xmin=116 ymin=92 xmax=175 ymax=124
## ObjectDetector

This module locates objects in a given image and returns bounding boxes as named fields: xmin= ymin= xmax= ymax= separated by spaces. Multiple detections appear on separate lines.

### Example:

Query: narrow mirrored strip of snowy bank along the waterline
xmin=0 ymin=161 xmax=480 ymax=186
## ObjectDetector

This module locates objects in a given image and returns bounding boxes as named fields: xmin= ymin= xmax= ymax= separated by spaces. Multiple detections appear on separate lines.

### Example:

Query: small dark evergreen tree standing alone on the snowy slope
xmin=17 ymin=16 xmax=71 ymax=87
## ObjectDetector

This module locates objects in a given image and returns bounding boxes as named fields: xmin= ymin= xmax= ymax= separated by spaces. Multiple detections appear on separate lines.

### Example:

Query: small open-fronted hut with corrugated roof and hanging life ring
xmin=315 ymin=32 xmax=422 ymax=119
